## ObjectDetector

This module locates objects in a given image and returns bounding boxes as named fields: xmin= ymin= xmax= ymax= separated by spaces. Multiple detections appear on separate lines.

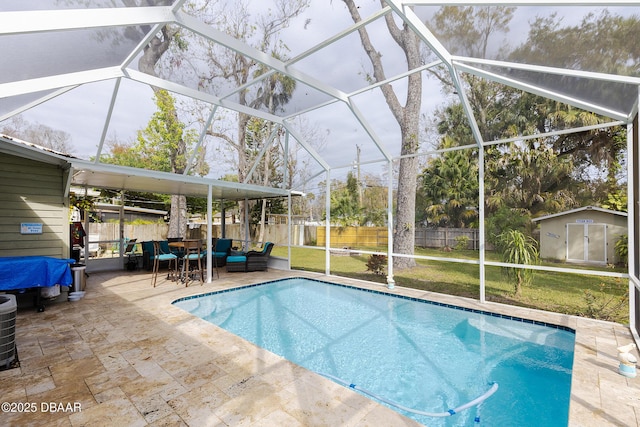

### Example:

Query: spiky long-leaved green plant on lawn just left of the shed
xmin=499 ymin=230 xmax=540 ymax=297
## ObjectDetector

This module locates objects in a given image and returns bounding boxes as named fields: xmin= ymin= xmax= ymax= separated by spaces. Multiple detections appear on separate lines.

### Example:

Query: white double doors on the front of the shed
xmin=567 ymin=223 xmax=607 ymax=264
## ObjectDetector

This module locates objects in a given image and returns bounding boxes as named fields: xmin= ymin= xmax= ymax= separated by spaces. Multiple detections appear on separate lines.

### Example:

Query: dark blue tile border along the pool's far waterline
xmin=171 ymin=276 xmax=576 ymax=335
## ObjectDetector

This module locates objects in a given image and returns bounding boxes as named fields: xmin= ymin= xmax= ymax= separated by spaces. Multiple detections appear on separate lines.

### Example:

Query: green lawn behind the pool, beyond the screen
xmin=272 ymin=246 xmax=629 ymax=324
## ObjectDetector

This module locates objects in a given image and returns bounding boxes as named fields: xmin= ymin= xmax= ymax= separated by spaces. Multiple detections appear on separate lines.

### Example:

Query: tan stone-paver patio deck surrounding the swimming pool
xmin=0 ymin=269 xmax=640 ymax=427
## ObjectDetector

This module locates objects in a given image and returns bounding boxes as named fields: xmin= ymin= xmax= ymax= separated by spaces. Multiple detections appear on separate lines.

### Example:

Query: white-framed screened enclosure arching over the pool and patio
xmin=0 ymin=0 xmax=640 ymax=339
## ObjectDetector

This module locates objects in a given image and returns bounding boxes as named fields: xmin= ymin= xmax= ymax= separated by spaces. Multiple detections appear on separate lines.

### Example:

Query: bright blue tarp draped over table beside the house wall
xmin=0 ymin=256 xmax=75 ymax=291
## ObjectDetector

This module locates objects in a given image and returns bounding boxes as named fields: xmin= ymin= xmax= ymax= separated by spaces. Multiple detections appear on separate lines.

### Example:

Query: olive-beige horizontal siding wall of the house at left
xmin=0 ymin=155 xmax=69 ymax=258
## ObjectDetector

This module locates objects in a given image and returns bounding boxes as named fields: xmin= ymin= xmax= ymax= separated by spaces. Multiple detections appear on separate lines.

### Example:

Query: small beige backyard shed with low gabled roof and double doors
xmin=533 ymin=206 xmax=627 ymax=264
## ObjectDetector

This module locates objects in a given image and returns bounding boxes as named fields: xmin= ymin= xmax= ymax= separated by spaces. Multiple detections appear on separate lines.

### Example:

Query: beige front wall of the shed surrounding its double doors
xmin=540 ymin=210 xmax=627 ymax=263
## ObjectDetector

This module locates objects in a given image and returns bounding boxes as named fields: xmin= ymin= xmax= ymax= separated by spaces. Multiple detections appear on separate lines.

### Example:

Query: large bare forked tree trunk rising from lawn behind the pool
xmin=343 ymin=0 xmax=422 ymax=269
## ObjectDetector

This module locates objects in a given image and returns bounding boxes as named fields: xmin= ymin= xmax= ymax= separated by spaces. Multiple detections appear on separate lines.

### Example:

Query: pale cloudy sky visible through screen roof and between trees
xmin=0 ymin=0 xmax=637 ymax=186
